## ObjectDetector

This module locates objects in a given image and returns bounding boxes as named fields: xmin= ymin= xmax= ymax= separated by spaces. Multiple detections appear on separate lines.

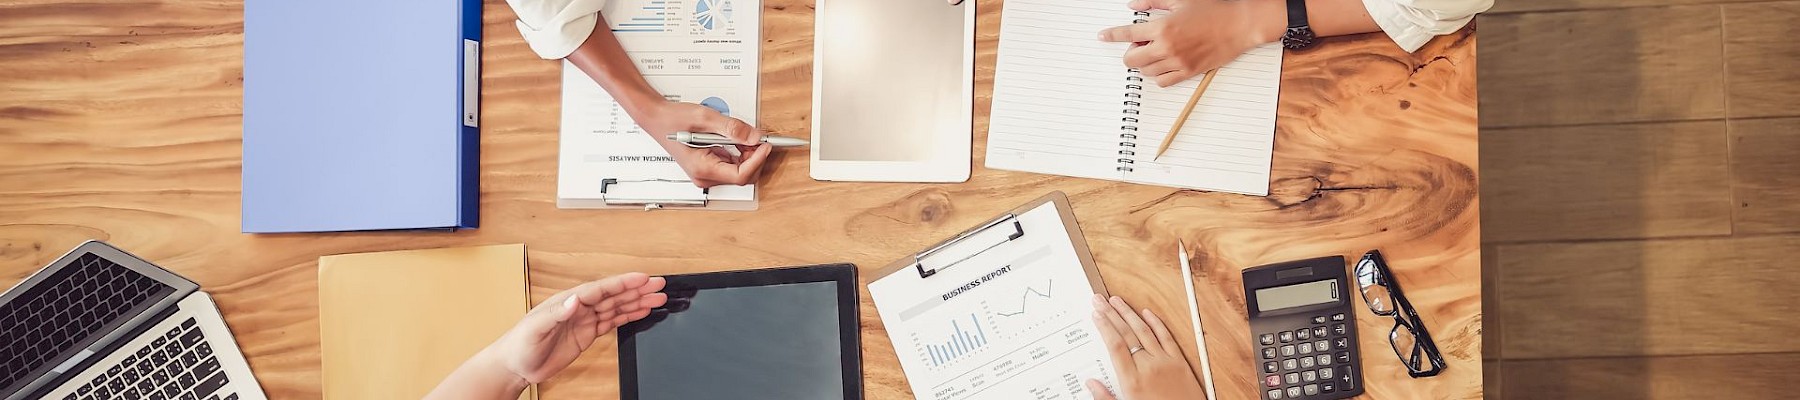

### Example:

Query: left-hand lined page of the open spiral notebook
xmin=986 ymin=0 xmax=1134 ymax=180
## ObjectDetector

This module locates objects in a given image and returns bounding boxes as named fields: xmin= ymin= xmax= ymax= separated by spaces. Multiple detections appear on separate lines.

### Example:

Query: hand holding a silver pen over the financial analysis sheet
xmin=637 ymin=101 xmax=774 ymax=187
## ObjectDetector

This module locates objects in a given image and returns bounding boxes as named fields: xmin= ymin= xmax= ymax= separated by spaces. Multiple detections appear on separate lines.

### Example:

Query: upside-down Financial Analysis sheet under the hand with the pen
xmin=556 ymin=0 xmax=761 ymax=209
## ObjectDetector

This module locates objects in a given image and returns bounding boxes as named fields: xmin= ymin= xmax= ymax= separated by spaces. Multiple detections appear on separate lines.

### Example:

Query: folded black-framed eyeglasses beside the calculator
xmin=1355 ymin=250 xmax=1444 ymax=378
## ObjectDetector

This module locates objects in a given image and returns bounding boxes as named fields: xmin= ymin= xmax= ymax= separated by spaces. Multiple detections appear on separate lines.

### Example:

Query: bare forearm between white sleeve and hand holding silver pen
xmin=569 ymin=16 xmax=664 ymax=119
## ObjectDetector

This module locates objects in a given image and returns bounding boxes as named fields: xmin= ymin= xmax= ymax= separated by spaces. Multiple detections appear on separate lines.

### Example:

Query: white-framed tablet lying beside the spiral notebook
xmin=812 ymin=0 xmax=976 ymax=182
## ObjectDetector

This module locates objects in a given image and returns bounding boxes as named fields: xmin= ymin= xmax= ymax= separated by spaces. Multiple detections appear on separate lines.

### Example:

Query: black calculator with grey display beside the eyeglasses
xmin=1244 ymin=256 xmax=1363 ymax=400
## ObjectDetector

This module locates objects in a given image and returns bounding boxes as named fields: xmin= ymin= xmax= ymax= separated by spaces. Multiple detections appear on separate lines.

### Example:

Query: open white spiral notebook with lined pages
xmin=986 ymin=0 xmax=1282 ymax=196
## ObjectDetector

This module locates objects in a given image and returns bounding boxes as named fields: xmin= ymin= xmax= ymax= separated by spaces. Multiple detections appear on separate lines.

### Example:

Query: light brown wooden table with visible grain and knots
xmin=0 ymin=0 xmax=1481 ymax=398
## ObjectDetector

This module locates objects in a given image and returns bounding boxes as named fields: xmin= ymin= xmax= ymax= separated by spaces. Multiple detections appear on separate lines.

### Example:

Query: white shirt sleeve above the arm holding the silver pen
xmin=506 ymin=0 xmax=607 ymax=59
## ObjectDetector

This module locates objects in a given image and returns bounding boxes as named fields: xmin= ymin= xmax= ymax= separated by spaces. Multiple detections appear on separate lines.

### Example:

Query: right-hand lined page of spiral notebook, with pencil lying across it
xmin=1130 ymin=43 xmax=1282 ymax=196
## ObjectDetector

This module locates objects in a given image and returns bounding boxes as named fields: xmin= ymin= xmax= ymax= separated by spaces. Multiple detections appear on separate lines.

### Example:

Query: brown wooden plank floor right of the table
xmin=1480 ymin=0 xmax=1800 ymax=398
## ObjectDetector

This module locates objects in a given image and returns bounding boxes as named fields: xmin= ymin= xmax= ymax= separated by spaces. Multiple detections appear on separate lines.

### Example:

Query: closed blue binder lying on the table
xmin=243 ymin=0 xmax=481 ymax=232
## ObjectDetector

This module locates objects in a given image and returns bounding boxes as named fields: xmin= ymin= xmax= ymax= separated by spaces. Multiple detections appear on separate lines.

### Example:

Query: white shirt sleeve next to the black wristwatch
xmin=1363 ymin=0 xmax=1494 ymax=52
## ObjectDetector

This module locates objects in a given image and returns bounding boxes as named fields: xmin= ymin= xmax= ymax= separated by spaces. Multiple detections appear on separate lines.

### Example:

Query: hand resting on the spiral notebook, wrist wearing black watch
xmin=1100 ymin=0 xmax=1287 ymax=86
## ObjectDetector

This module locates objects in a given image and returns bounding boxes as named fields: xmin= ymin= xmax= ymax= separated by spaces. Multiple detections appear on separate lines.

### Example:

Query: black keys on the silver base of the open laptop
xmin=63 ymin=317 xmax=238 ymax=400
